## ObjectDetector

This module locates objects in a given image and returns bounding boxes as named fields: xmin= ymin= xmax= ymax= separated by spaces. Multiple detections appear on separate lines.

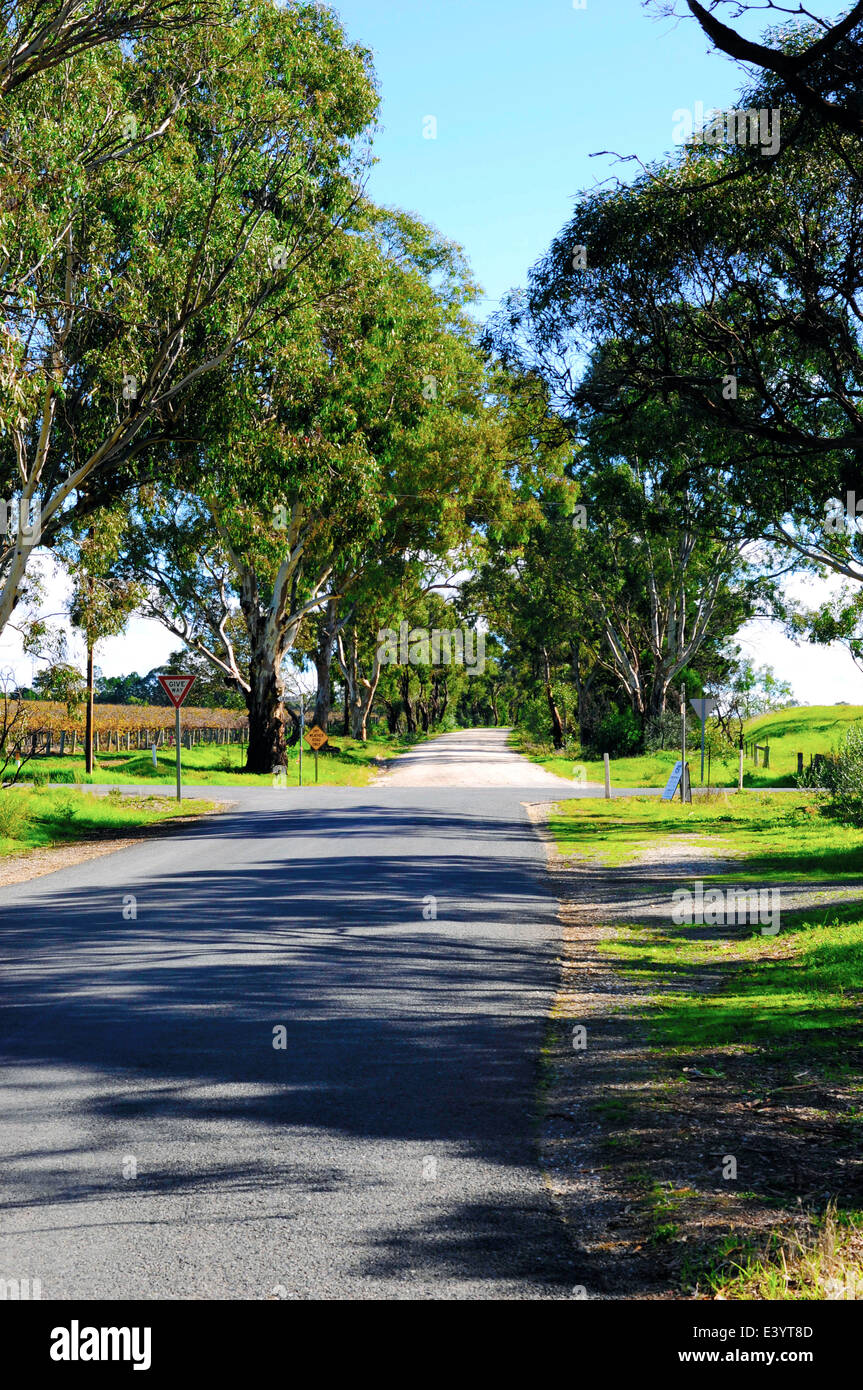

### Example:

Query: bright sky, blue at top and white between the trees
xmin=0 ymin=0 xmax=863 ymax=703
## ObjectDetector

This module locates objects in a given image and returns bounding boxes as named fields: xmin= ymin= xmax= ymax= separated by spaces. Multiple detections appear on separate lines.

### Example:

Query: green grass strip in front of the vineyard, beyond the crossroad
xmin=11 ymin=734 xmax=425 ymax=787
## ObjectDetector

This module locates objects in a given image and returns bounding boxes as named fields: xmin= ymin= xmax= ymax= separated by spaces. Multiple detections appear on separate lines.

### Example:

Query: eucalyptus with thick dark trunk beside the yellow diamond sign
xmin=118 ymin=206 xmax=502 ymax=771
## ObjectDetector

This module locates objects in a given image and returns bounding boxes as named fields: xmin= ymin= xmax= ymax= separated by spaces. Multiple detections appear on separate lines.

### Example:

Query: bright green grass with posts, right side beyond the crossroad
xmin=510 ymin=705 xmax=863 ymax=787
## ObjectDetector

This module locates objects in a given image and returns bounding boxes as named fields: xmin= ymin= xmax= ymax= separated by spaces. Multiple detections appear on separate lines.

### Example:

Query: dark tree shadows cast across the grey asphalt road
xmin=0 ymin=805 xmax=573 ymax=1293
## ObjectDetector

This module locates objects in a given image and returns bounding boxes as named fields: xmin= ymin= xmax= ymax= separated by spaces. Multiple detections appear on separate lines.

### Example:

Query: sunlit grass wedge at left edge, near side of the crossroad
xmin=0 ymin=787 xmax=215 ymax=858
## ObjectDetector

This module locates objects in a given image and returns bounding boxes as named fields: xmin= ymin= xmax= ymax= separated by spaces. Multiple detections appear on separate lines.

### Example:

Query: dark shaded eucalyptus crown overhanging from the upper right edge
xmin=483 ymin=44 xmax=863 ymax=631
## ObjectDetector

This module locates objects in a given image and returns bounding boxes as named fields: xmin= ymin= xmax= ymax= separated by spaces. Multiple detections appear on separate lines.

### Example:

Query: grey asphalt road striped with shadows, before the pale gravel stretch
xmin=0 ymin=735 xmax=580 ymax=1300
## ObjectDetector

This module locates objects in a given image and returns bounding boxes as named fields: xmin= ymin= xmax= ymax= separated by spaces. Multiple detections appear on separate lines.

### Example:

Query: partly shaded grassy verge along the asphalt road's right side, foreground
xmin=549 ymin=792 xmax=863 ymax=1300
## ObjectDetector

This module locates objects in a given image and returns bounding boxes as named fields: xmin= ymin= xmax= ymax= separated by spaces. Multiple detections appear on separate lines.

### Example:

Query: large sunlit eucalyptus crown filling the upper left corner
xmin=0 ymin=0 xmax=377 ymax=631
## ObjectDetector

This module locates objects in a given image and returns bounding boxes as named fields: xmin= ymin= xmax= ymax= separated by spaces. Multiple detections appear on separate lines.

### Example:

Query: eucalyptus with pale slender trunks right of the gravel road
xmin=468 ymin=363 xmax=775 ymax=748
